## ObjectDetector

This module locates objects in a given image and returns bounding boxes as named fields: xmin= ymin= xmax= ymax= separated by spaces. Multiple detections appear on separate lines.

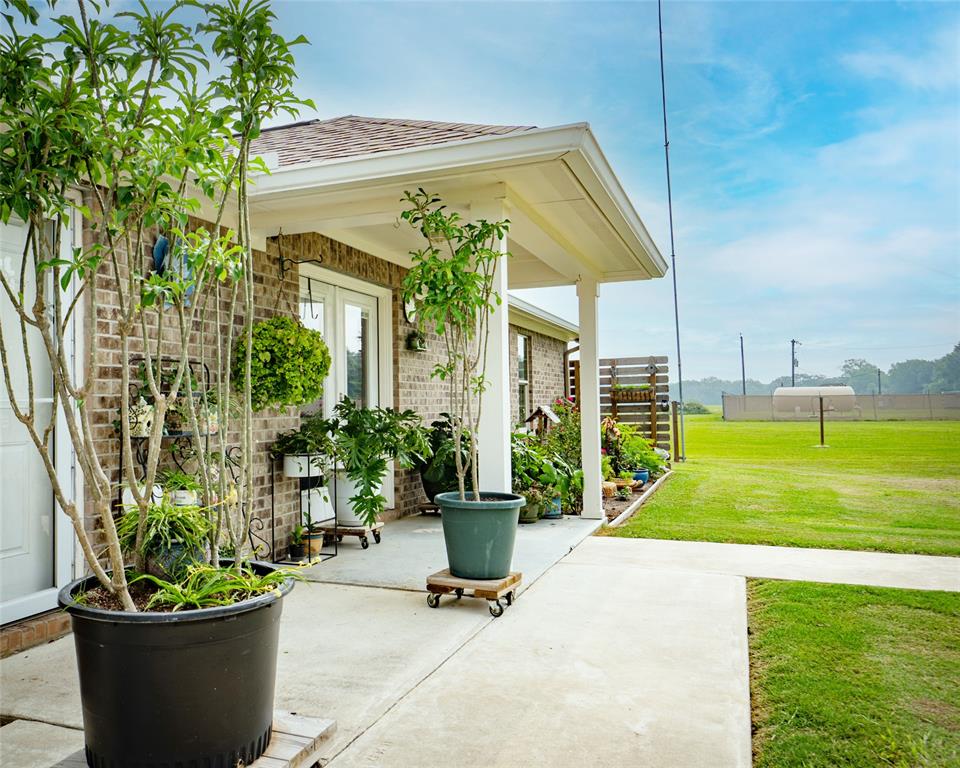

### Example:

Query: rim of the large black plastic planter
xmin=57 ymin=560 xmax=294 ymax=624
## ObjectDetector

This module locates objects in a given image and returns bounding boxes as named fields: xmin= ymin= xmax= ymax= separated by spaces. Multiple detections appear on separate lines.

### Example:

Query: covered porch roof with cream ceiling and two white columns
xmin=251 ymin=118 xmax=666 ymax=520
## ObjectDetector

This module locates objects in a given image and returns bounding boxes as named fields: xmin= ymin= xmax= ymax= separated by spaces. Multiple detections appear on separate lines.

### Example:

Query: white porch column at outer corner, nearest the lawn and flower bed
xmin=577 ymin=276 xmax=603 ymax=520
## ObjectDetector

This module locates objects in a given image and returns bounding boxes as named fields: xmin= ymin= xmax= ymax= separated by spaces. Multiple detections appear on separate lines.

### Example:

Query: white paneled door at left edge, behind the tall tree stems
xmin=0 ymin=216 xmax=72 ymax=623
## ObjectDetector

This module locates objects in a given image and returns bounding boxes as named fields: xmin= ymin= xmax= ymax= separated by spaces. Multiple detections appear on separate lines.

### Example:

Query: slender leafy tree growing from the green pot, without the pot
xmin=400 ymin=188 xmax=510 ymax=501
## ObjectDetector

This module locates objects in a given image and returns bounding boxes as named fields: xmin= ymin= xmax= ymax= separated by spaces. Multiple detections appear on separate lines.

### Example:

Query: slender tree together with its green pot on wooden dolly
xmin=401 ymin=189 xmax=524 ymax=579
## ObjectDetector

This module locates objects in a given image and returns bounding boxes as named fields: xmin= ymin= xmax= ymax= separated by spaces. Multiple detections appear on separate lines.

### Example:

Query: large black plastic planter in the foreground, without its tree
xmin=59 ymin=563 xmax=293 ymax=768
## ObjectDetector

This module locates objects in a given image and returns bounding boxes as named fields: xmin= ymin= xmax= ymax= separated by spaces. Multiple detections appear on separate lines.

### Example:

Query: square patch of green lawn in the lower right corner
xmin=749 ymin=581 xmax=960 ymax=768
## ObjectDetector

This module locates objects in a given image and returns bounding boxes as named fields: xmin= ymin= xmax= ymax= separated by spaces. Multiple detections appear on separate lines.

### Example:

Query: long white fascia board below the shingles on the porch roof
xmin=250 ymin=123 xmax=589 ymax=200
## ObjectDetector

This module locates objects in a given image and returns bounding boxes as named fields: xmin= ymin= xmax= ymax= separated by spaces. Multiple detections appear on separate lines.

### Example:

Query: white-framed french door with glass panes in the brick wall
xmin=300 ymin=267 xmax=394 ymax=507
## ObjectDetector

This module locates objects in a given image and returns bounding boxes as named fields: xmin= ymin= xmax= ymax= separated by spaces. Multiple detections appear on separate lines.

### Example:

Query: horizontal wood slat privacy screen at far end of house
xmin=567 ymin=356 xmax=671 ymax=450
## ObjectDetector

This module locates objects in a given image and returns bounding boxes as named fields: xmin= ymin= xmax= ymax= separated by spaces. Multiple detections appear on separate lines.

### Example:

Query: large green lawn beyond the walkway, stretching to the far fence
xmin=604 ymin=414 xmax=960 ymax=555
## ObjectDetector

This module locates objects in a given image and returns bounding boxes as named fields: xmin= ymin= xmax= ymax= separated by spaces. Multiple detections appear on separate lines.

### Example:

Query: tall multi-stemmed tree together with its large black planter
xmin=0 ymin=0 xmax=305 ymax=768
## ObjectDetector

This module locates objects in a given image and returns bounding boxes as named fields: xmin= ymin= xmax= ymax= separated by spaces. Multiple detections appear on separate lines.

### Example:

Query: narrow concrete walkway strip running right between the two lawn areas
xmin=564 ymin=536 xmax=960 ymax=592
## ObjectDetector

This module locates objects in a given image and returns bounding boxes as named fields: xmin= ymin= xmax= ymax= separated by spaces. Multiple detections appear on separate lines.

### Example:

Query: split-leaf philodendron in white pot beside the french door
xmin=328 ymin=397 xmax=430 ymax=527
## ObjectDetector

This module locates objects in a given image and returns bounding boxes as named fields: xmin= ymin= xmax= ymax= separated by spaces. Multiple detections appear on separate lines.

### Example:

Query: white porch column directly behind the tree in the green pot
xmin=470 ymin=199 xmax=512 ymax=492
